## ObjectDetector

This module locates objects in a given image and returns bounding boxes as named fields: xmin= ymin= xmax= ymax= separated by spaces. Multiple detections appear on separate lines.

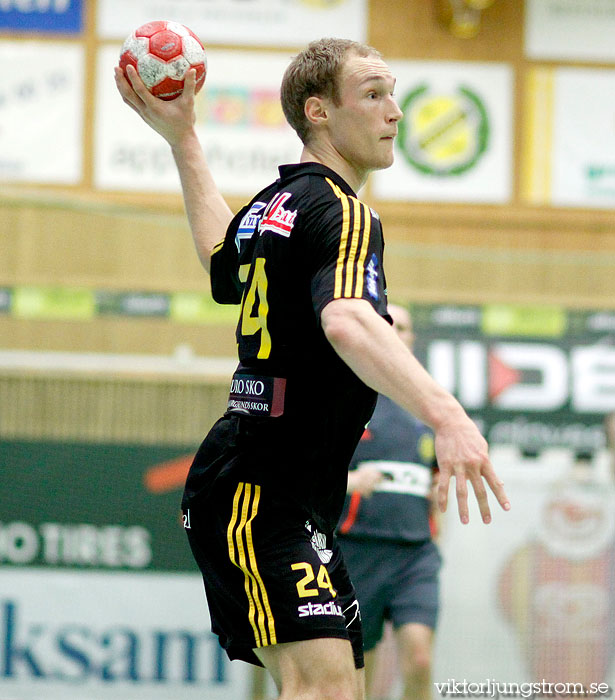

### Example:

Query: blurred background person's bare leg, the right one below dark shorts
xmin=395 ymin=622 xmax=433 ymax=700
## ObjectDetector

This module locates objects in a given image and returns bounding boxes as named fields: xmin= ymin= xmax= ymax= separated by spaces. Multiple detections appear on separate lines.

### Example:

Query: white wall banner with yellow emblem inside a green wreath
xmin=372 ymin=61 xmax=513 ymax=203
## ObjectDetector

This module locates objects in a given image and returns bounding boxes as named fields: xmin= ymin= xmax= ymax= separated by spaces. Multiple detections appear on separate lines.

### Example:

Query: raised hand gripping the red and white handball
xmin=115 ymin=65 xmax=196 ymax=147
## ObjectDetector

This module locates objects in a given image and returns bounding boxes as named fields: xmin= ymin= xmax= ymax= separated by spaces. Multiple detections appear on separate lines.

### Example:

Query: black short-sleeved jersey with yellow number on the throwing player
xmin=184 ymin=163 xmax=388 ymax=532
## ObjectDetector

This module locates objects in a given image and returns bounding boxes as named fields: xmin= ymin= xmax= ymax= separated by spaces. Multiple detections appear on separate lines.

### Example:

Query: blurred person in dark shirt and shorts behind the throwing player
xmin=338 ymin=304 xmax=440 ymax=700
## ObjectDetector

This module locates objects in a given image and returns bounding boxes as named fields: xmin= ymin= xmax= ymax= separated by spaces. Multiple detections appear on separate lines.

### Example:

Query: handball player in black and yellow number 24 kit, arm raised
xmin=115 ymin=39 xmax=508 ymax=700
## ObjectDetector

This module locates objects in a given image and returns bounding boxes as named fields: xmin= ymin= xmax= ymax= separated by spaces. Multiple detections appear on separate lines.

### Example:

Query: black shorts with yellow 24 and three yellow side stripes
xmin=184 ymin=478 xmax=363 ymax=668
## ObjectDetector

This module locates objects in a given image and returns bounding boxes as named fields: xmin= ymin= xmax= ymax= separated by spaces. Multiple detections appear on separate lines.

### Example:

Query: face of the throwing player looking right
xmin=329 ymin=54 xmax=402 ymax=173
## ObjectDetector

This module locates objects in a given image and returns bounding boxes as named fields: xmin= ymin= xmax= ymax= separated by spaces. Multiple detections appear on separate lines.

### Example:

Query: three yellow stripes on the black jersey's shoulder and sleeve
xmin=325 ymin=178 xmax=371 ymax=299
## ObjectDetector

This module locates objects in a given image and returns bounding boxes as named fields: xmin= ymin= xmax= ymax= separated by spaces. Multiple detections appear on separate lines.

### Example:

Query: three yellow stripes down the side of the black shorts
xmin=227 ymin=482 xmax=276 ymax=647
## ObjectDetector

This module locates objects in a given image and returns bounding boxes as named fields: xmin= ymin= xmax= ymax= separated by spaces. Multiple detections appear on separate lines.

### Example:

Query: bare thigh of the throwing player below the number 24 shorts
xmin=254 ymin=639 xmax=365 ymax=700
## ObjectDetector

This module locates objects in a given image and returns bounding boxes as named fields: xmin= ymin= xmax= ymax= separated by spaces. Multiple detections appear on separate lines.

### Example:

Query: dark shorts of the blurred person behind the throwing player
xmin=339 ymin=537 xmax=442 ymax=651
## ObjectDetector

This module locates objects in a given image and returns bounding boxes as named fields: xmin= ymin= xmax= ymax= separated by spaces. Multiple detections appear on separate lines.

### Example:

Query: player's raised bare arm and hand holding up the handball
xmin=115 ymin=66 xmax=233 ymax=272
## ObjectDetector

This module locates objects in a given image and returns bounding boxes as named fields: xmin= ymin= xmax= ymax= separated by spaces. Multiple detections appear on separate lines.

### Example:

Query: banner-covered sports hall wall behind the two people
xmin=0 ymin=0 xmax=615 ymax=700
